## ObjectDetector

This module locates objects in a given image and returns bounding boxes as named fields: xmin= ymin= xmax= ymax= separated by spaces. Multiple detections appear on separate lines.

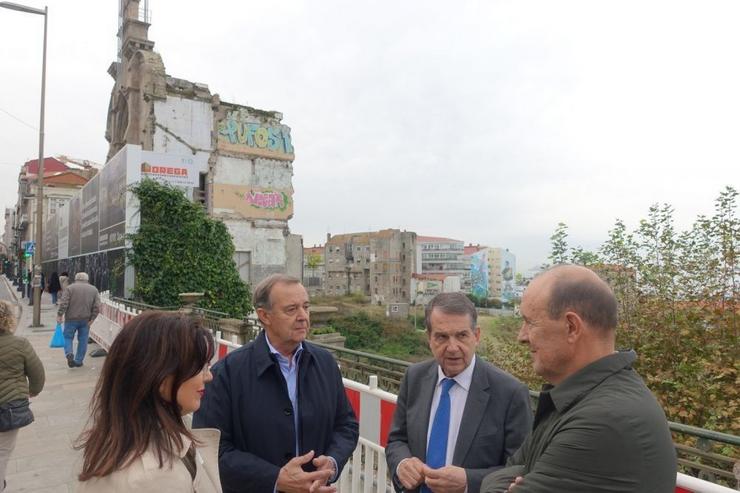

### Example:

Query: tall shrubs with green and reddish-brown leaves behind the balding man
xmin=536 ymin=187 xmax=740 ymax=434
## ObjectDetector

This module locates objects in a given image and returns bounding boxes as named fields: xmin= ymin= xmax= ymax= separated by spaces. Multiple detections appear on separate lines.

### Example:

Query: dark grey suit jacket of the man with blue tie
xmin=385 ymin=357 xmax=532 ymax=493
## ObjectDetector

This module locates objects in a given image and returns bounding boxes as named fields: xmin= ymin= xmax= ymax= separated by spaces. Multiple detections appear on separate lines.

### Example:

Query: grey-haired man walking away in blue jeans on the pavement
xmin=57 ymin=272 xmax=100 ymax=368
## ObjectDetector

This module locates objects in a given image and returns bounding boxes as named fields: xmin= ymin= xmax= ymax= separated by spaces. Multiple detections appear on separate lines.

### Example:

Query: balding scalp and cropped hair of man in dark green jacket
xmin=532 ymin=265 xmax=617 ymax=330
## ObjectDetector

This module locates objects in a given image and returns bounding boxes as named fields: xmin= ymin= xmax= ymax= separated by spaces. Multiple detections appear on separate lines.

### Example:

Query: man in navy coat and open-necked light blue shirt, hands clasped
xmin=193 ymin=274 xmax=359 ymax=493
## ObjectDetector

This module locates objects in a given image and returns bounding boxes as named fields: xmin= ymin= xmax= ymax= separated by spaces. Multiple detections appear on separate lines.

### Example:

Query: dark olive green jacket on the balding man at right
xmin=481 ymin=351 xmax=676 ymax=493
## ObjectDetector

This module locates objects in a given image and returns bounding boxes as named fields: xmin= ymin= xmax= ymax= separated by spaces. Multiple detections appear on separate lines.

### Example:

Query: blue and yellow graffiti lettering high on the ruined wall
xmin=218 ymin=111 xmax=293 ymax=154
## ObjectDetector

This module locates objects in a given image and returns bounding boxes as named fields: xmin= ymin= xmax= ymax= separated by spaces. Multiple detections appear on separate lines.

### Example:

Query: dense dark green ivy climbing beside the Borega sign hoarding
xmin=128 ymin=180 xmax=252 ymax=317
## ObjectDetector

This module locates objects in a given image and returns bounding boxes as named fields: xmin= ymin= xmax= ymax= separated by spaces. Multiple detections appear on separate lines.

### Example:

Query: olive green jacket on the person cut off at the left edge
xmin=0 ymin=333 xmax=46 ymax=404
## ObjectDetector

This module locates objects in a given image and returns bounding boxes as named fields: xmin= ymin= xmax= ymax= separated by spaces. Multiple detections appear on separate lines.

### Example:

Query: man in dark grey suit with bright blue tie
xmin=385 ymin=293 xmax=532 ymax=493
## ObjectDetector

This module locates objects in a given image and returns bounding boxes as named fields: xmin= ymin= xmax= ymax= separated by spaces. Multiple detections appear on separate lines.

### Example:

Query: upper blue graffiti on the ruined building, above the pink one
xmin=218 ymin=110 xmax=294 ymax=161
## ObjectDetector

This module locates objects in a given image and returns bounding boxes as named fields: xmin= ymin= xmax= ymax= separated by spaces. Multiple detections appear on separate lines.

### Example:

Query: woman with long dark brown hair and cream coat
xmin=77 ymin=311 xmax=221 ymax=493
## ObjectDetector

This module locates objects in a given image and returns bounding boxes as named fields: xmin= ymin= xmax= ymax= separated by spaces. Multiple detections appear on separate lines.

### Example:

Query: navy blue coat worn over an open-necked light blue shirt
xmin=193 ymin=331 xmax=359 ymax=493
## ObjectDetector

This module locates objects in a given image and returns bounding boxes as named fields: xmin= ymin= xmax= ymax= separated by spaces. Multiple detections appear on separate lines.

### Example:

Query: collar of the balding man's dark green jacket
xmin=543 ymin=349 xmax=637 ymax=412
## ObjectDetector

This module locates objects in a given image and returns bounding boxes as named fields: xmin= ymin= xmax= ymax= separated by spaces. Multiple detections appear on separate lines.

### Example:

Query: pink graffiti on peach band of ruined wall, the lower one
xmin=213 ymin=184 xmax=293 ymax=220
